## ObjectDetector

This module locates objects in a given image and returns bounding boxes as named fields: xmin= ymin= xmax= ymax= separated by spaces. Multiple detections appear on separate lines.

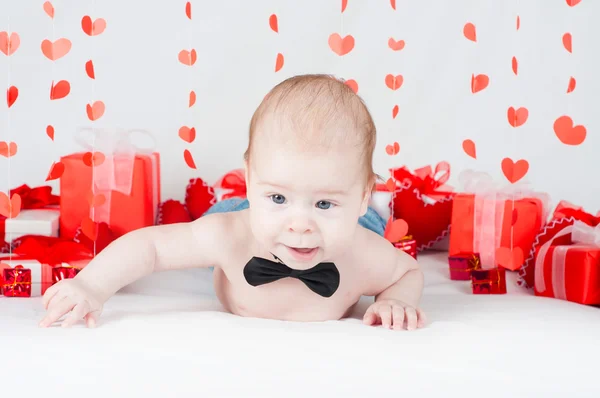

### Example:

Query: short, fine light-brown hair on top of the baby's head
xmin=244 ymin=74 xmax=376 ymax=190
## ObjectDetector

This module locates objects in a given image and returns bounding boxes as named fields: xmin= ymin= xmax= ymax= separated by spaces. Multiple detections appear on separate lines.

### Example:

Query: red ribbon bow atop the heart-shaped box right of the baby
xmin=390 ymin=162 xmax=453 ymax=199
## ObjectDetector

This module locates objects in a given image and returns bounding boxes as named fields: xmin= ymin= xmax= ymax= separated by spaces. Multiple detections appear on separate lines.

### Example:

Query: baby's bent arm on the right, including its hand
xmin=364 ymin=232 xmax=425 ymax=330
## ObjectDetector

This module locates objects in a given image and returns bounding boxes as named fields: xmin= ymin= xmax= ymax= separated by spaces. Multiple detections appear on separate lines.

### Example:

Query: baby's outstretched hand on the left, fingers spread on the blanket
xmin=40 ymin=278 xmax=103 ymax=327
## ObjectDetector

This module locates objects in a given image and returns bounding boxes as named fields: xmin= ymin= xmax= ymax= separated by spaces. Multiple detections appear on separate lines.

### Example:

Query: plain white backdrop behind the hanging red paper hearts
xmin=0 ymin=0 xmax=600 ymax=212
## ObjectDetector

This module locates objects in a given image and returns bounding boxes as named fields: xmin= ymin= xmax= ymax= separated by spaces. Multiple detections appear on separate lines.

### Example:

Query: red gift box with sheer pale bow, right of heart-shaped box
xmin=448 ymin=171 xmax=549 ymax=271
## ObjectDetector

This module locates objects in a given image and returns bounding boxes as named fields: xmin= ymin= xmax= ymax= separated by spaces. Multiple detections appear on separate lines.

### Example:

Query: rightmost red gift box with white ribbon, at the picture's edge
xmin=534 ymin=220 xmax=600 ymax=305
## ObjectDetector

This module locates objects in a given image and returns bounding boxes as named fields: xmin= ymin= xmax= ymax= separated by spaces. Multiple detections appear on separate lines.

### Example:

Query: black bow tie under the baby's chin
xmin=244 ymin=256 xmax=340 ymax=297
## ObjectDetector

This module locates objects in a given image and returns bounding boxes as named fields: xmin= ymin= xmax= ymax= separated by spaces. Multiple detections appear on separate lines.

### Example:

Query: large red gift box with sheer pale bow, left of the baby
xmin=60 ymin=129 xmax=160 ymax=240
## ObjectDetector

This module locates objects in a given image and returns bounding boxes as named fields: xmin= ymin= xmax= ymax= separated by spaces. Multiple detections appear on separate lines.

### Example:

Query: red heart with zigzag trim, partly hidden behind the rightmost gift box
xmin=518 ymin=201 xmax=600 ymax=289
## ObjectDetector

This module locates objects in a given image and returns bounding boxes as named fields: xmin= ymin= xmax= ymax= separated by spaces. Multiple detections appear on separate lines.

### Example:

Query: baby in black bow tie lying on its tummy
xmin=40 ymin=75 xmax=426 ymax=330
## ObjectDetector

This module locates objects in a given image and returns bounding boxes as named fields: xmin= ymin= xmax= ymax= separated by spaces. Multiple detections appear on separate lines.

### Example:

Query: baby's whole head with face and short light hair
xmin=245 ymin=75 xmax=376 ymax=268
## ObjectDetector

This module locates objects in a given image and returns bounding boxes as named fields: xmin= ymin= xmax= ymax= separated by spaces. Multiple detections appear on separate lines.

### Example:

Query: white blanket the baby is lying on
xmin=0 ymin=253 xmax=600 ymax=398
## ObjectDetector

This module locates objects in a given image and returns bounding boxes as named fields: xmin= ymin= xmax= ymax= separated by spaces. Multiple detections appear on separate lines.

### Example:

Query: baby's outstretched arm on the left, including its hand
xmin=40 ymin=214 xmax=228 ymax=327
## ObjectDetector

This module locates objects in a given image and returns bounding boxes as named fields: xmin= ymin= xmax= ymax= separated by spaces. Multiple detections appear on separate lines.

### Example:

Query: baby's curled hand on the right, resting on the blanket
xmin=363 ymin=300 xmax=426 ymax=330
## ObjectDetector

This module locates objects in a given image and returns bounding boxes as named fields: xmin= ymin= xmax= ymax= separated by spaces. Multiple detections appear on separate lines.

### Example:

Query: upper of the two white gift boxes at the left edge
xmin=4 ymin=207 xmax=60 ymax=242
